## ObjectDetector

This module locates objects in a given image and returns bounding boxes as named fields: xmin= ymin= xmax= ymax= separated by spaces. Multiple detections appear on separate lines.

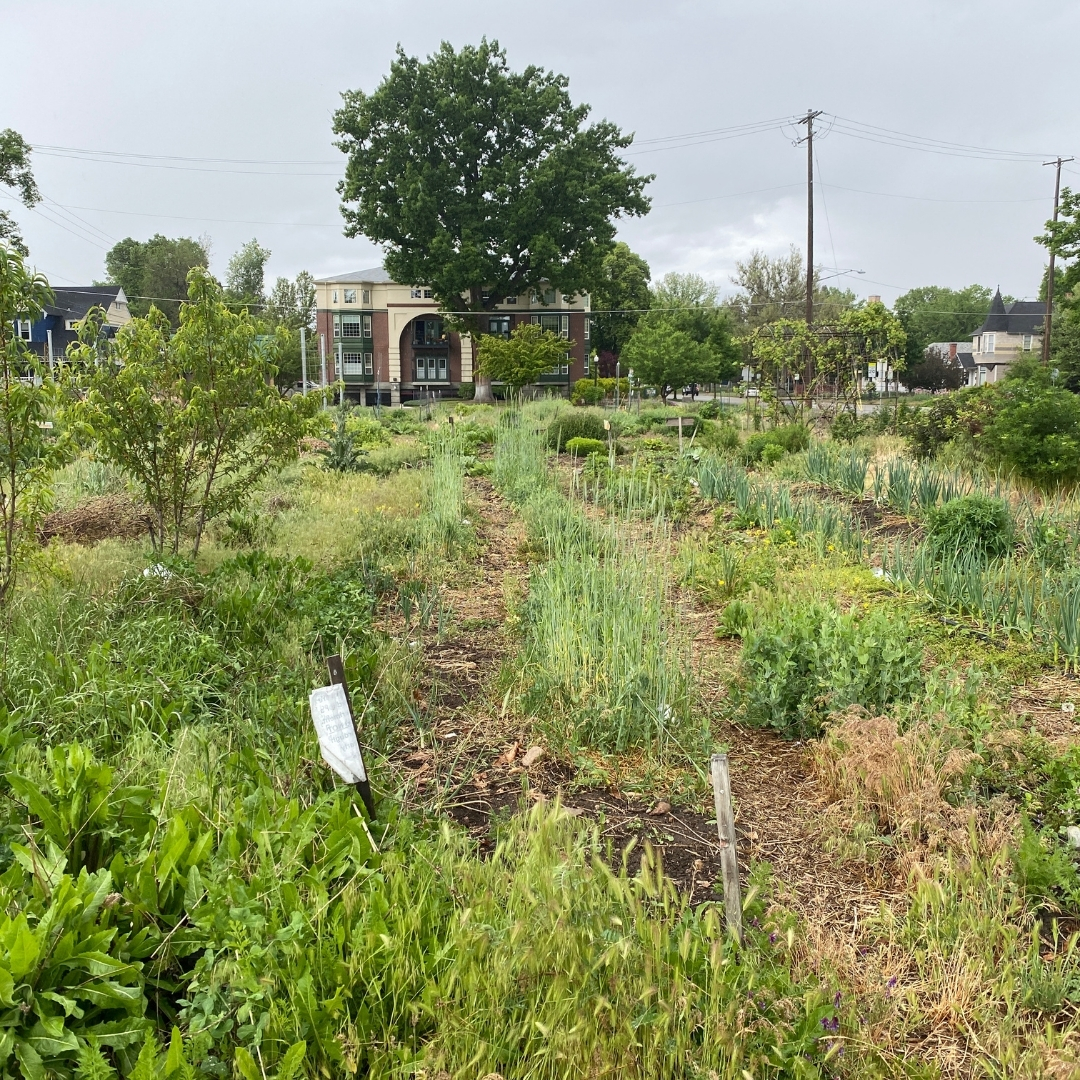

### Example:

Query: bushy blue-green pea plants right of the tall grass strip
xmin=737 ymin=604 xmax=922 ymax=739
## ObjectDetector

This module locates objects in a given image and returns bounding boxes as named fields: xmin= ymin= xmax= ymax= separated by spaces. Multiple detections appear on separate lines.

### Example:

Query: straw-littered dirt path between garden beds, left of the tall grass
xmin=393 ymin=477 xmax=734 ymax=901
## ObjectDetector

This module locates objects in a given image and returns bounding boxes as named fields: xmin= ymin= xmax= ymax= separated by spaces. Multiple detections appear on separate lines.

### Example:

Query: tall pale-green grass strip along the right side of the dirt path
xmin=496 ymin=416 xmax=691 ymax=755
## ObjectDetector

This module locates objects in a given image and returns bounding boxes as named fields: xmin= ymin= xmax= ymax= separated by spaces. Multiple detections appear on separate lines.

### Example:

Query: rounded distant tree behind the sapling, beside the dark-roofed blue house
xmin=105 ymin=232 xmax=210 ymax=327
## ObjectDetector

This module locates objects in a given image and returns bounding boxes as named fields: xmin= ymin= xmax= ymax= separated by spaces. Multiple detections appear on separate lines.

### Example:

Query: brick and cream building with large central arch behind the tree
xmin=308 ymin=267 xmax=591 ymax=405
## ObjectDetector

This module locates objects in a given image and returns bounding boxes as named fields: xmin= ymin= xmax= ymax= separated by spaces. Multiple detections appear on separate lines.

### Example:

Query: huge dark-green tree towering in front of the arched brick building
xmin=334 ymin=39 xmax=651 ymax=401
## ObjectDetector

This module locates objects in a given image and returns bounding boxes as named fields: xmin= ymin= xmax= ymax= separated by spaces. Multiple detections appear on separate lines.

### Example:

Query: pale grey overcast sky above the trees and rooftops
xmin=0 ymin=0 xmax=1080 ymax=301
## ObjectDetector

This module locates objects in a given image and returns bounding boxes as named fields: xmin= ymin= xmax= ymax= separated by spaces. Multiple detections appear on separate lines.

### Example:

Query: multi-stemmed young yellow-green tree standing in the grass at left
xmin=68 ymin=267 xmax=315 ymax=554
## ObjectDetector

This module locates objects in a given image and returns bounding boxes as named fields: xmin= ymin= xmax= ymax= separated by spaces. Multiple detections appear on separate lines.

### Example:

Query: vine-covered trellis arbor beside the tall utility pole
xmin=747 ymin=302 xmax=907 ymax=419
